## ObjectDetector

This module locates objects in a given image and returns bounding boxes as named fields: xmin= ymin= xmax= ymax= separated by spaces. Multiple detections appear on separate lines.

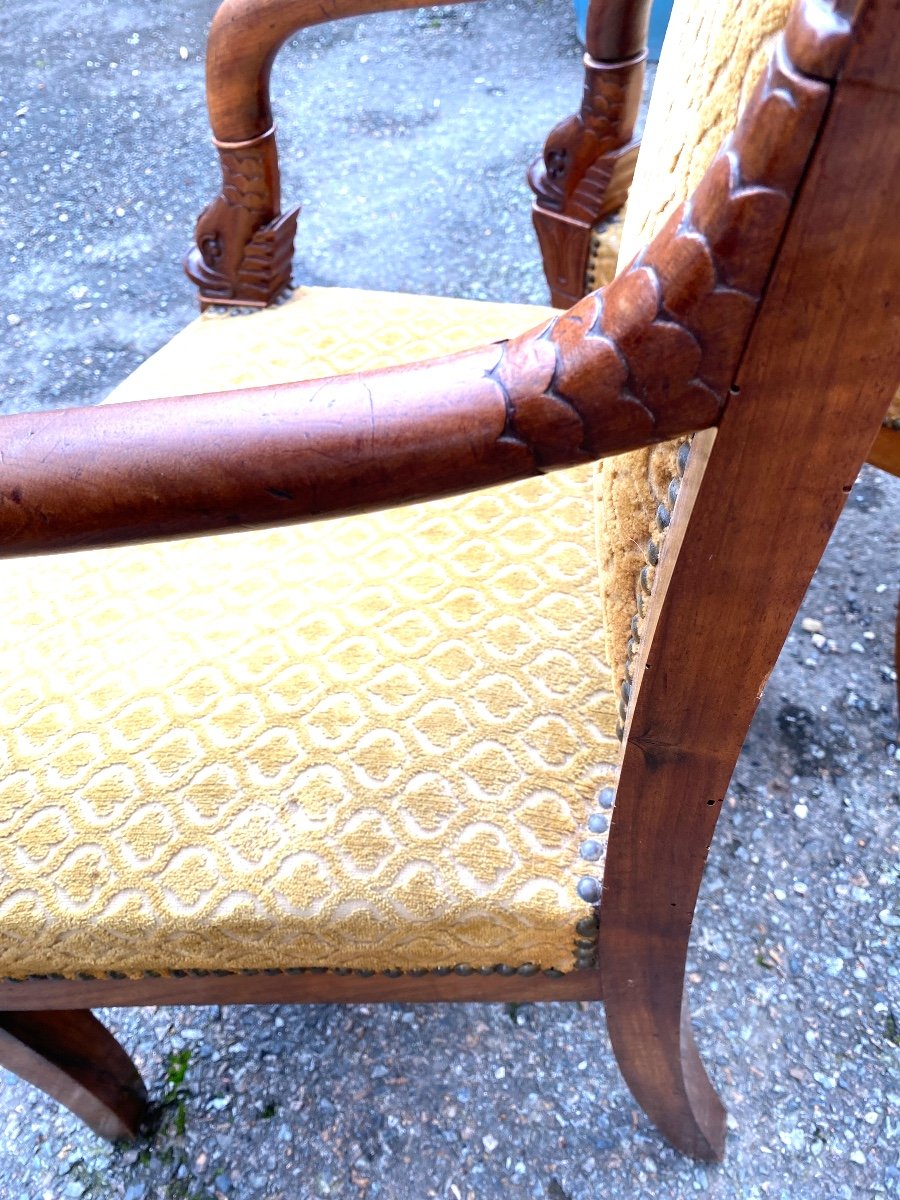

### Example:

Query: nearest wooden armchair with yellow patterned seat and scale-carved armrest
xmin=0 ymin=0 xmax=900 ymax=1158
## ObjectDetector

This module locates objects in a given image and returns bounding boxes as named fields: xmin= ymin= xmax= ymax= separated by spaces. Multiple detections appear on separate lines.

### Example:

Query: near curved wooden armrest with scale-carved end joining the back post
xmin=0 ymin=9 xmax=845 ymax=554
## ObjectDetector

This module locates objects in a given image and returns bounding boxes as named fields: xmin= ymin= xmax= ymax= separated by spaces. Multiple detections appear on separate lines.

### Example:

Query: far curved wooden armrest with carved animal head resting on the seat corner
xmin=185 ymin=0 xmax=475 ymax=308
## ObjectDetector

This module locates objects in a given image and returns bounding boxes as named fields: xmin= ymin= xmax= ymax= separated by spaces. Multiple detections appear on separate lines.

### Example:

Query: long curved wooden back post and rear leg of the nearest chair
xmin=600 ymin=0 xmax=900 ymax=1158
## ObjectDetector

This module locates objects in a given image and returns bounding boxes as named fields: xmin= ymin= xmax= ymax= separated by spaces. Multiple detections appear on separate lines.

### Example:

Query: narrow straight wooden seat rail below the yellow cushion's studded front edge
xmin=0 ymin=968 xmax=602 ymax=1012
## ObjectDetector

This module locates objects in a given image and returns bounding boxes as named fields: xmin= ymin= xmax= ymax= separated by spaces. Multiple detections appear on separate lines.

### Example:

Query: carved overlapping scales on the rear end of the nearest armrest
xmin=508 ymin=36 xmax=828 ymax=469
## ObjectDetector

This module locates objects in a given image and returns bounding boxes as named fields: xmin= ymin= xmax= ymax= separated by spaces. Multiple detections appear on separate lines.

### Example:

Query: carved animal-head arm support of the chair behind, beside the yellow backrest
xmin=528 ymin=0 xmax=650 ymax=308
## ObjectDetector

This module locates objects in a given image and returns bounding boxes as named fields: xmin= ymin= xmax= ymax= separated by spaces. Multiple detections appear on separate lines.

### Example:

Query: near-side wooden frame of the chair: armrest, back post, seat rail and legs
xmin=0 ymin=0 xmax=900 ymax=1159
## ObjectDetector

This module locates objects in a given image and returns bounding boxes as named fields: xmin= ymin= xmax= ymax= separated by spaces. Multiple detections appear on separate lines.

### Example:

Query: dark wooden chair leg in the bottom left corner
xmin=0 ymin=1009 xmax=146 ymax=1140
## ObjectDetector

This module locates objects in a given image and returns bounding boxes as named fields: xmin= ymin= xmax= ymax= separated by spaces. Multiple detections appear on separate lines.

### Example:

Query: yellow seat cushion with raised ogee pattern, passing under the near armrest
xmin=0 ymin=292 xmax=617 ymax=977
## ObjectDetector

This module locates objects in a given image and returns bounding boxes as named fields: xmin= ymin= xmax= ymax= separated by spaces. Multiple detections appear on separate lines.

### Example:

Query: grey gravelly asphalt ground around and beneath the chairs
xmin=0 ymin=0 xmax=900 ymax=1200
